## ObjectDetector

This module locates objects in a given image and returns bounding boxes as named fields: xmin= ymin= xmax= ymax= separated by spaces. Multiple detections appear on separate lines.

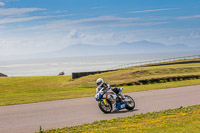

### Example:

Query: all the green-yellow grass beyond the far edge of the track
xmin=0 ymin=58 xmax=200 ymax=106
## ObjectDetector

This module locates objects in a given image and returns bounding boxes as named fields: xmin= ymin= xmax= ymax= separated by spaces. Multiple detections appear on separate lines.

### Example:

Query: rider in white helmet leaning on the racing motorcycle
xmin=96 ymin=78 xmax=125 ymax=100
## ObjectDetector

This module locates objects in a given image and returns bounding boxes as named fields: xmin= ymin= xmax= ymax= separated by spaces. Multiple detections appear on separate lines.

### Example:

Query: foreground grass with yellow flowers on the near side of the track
xmin=42 ymin=105 xmax=200 ymax=133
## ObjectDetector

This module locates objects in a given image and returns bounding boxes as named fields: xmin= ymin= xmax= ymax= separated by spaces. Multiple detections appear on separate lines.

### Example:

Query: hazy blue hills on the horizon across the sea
xmin=51 ymin=41 xmax=200 ymax=57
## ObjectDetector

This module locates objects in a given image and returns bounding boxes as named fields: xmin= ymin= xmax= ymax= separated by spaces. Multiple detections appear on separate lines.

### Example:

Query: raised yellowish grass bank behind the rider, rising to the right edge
xmin=61 ymin=63 xmax=200 ymax=88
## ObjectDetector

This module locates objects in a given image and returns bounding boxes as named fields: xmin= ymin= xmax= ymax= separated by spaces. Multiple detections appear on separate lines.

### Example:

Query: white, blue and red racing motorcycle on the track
xmin=95 ymin=87 xmax=135 ymax=113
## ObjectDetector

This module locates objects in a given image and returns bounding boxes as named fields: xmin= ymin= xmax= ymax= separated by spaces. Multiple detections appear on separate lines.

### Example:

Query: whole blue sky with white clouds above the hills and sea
xmin=0 ymin=0 xmax=200 ymax=57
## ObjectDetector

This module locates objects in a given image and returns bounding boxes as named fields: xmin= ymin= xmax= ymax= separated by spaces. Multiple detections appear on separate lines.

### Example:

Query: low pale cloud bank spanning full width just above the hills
xmin=0 ymin=28 xmax=200 ymax=56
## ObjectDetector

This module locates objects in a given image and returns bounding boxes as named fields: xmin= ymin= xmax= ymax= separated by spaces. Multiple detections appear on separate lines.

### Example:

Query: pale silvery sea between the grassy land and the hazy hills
xmin=0 ymin=52 xmax=200 ymax=77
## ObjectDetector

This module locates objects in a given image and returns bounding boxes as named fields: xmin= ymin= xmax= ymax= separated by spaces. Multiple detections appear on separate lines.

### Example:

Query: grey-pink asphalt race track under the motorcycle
xmin=0 ymin=85 xmax=200 ymax=133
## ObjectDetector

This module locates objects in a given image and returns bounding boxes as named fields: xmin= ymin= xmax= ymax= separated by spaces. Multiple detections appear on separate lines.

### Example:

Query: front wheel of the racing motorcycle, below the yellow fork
xmin=99 ymin=99 xmax=112 ymax=113
